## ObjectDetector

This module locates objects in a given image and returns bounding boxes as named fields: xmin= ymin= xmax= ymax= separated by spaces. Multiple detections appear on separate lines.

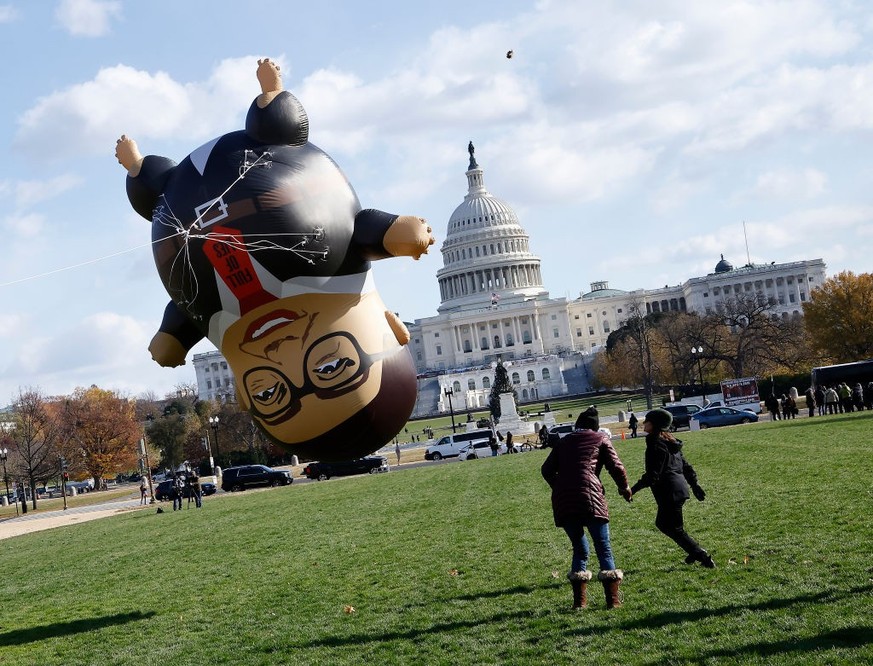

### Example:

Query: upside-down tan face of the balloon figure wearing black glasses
xmin=222 ymin=293 xmax=399 ymax=444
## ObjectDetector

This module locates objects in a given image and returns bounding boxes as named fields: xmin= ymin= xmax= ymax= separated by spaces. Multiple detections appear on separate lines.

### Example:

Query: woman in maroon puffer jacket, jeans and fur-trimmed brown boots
xmin=541 ymin=407 xmax=631 ymax=608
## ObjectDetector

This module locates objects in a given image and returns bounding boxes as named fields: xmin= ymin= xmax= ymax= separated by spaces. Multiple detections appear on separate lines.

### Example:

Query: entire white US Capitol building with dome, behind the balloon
xmin=193 ymin=143 xmax=825 ymax=416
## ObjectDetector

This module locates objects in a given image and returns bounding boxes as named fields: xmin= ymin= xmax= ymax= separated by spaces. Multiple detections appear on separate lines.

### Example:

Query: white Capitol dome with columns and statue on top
xmin=437 ymin=142 xmax=548 ymax=312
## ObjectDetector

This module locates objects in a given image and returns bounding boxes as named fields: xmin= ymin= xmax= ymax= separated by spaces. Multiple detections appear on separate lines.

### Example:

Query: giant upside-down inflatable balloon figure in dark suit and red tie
xmin=116 ymin=59 xmax=434 ymax=460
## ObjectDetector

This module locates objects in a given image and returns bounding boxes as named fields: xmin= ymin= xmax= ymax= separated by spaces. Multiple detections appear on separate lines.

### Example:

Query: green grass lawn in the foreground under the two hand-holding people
xmin=0 ymin=412 xmax=873 ymax=666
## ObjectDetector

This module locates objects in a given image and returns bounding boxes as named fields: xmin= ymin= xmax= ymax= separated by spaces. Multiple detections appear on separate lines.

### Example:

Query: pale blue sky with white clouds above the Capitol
xmin=0 ymin=0 xmax=873 ymax=404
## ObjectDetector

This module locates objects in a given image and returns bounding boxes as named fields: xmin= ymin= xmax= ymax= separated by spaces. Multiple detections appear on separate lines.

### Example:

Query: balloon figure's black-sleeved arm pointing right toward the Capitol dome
xmin=354 ymin=208 xmax=434 ymax=261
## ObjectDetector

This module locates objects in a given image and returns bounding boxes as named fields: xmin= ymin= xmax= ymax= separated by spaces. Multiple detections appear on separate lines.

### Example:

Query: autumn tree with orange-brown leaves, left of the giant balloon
xmin=61 ymin=386 xmax=141 ymax=488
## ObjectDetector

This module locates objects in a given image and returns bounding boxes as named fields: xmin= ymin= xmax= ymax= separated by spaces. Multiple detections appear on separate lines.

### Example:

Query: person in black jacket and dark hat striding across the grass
xmin=631 ymin=409 xmax=715 ymax=569
